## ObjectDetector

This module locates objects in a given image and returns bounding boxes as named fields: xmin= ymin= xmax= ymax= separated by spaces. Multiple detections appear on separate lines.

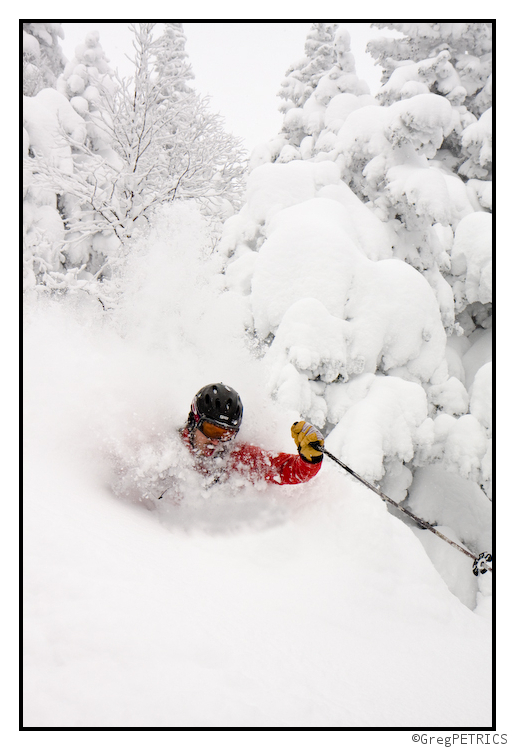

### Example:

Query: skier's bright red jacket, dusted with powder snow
xmin=182 ymin=428 xmax=322 ymax=484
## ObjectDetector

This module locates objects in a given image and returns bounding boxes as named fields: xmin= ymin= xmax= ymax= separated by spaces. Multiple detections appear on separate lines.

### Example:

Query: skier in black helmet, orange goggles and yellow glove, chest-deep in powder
xmin=182 ymin=383 xmax=324 ymax=484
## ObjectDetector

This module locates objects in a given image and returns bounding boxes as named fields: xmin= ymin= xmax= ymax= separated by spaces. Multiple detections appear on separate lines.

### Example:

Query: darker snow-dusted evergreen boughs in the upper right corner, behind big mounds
xmin=367 ymin=21 xmax=493 ymax=188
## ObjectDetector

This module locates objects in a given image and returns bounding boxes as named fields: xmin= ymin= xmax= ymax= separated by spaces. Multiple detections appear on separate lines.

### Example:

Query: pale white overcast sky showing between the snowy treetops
xmin=61 ymin=21 xmax=383 ymax=151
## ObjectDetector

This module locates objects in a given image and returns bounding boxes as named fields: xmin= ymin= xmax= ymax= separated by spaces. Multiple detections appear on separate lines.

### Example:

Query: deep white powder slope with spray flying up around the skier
xmin=24 ymin=204 xmax=492 ymax=729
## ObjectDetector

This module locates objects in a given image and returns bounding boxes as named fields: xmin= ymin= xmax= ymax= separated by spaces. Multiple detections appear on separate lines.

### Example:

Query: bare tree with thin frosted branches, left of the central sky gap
xmin=24 ymin=24 xmax=246 ymax=262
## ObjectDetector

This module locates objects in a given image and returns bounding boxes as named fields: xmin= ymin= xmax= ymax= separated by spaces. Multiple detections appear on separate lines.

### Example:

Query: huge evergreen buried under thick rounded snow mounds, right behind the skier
xmin=221 ymin=19 xmax=491 ymax=580
